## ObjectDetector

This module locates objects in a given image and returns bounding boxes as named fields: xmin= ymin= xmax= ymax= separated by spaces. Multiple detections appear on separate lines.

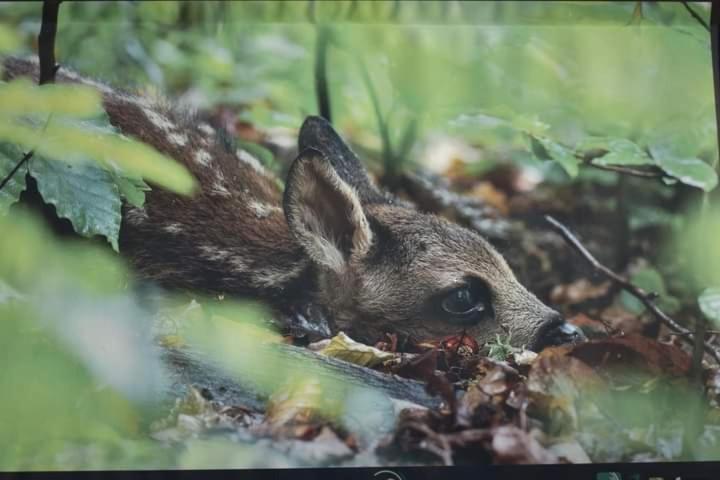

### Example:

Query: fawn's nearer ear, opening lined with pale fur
xmin=283 ymin=149 xmax=372 ymax=273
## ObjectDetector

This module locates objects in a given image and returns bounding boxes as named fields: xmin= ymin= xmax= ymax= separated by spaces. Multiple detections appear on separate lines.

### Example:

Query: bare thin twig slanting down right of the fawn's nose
xmin=545 ymin=215 xmax=720 ymax=363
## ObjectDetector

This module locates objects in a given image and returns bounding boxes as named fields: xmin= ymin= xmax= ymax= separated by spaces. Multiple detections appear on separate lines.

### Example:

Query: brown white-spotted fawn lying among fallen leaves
xmin=5 ymin=59 xmax=581 ymax=349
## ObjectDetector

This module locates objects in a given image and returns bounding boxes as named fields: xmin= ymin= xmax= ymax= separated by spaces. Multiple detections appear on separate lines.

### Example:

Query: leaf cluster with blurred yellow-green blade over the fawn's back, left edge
xmin=0 ymin=79 xmax=195 ymax=250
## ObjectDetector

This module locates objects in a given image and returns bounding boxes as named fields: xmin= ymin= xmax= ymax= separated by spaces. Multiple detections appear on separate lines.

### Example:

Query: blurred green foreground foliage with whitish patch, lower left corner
xmin=0 ymin=214 xmax=163 ymax=471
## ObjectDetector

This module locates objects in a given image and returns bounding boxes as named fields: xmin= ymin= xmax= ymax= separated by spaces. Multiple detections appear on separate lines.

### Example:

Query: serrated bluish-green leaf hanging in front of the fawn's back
xmin=30 ymin=154 xmax=121 ymax=251
